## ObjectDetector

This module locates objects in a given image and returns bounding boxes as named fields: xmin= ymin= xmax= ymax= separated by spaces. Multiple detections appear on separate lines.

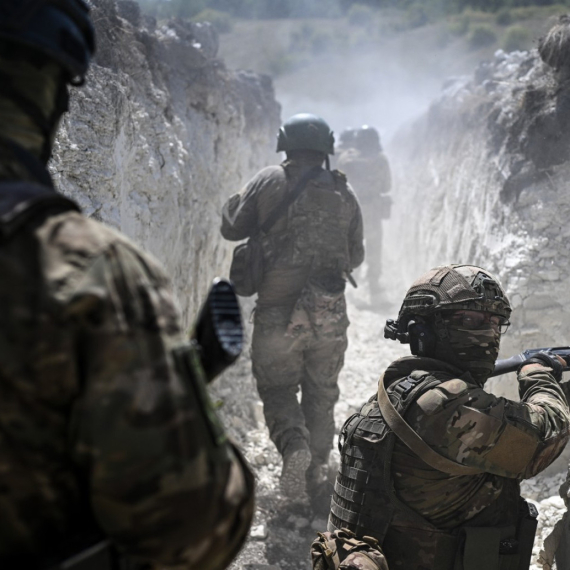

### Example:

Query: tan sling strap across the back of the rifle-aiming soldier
xmin=378 ymin=374 xmax=483 ymax=475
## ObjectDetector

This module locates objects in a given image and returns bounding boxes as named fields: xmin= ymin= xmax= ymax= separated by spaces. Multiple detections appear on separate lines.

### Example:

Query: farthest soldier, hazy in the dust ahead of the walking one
xmin=337 ymin=125 xmax=392 ymax=305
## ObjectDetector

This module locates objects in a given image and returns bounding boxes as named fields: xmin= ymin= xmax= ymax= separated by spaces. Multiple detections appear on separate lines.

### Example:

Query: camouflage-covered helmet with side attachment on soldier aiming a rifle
xmin=384 ymin=265 xmax=511 ymax=344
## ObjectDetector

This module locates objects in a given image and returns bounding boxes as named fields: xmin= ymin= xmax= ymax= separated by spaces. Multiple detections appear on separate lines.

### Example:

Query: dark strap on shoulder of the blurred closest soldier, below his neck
xmin=0 ymin=182 xmax=81 ymax=240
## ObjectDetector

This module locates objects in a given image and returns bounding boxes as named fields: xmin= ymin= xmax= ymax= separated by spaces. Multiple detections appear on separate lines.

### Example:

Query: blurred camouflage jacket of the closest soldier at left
xmin=0 ymin=158 xmax=253 ymax=570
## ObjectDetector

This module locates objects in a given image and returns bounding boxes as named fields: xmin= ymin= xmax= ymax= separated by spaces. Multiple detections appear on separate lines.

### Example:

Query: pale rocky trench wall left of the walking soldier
xmin=50 ymin=0 xmax=280 ymax=326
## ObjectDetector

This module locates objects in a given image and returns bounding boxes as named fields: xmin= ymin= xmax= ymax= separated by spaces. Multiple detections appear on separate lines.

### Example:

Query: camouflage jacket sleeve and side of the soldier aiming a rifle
xmin=386 ymin=357 xmax=570 ymax=529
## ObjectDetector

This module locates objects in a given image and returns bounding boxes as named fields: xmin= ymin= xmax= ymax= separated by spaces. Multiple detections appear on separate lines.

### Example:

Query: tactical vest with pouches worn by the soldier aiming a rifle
xmin=328 ymin=371 xmax=538 ymax=570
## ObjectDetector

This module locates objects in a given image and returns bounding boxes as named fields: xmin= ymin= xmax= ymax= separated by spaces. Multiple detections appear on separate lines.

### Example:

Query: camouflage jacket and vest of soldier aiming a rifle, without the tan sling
xmin=328 ymin=357 xmax=570 ymax=570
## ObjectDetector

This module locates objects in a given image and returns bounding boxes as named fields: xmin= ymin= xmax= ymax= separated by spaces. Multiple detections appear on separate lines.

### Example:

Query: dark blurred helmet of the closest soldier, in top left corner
xmin=0 ymin=0 xmax=95 ymax=85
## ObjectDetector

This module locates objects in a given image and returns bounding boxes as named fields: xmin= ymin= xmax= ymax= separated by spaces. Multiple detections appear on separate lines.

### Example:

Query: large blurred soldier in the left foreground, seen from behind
xmin=0 ymin=0 xmax=253 ymax=570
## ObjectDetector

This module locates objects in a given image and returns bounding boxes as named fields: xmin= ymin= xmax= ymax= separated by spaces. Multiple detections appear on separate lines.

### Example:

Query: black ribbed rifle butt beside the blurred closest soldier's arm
xmin=191 ymin=278 xmax=243 ymax=382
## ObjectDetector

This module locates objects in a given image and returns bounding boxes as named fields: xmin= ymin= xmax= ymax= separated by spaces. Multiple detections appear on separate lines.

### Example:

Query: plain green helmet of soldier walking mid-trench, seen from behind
xmin=277 ymin=113 xmax=334 ymax=154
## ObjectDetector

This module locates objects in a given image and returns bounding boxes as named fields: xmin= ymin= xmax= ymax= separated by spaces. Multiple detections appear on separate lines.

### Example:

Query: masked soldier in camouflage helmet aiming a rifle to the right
xmin=328 ymin=265 xmax=570 ymax=570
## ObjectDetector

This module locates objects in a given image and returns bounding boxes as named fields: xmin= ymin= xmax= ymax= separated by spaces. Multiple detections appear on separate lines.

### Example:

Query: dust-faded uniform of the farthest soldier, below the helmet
xmin=338 ymin=148 xmax=392 ymax=295
